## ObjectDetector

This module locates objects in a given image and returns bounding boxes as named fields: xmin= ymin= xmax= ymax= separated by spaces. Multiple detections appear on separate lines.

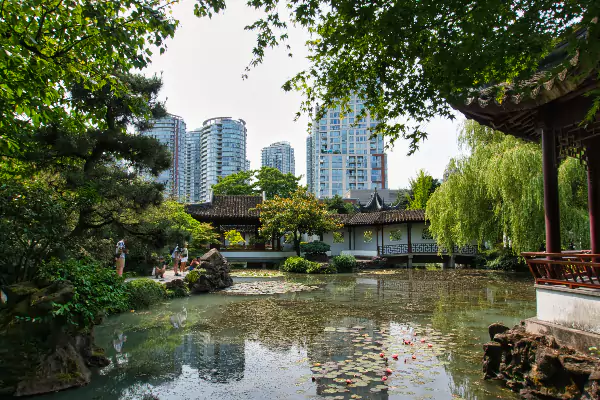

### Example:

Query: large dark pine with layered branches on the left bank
xmin=0 ymin=74 xmax=183 ymax=281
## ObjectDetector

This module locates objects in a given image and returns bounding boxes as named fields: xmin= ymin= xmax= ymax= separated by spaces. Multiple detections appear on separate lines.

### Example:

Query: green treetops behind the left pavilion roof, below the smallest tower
xmin=212 ymin=167 xmax=300 ymax=199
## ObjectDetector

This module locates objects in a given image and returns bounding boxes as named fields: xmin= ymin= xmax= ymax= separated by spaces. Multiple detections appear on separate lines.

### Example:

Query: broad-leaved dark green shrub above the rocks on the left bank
xmin=39 ymin=260 xmax=128 ymax=328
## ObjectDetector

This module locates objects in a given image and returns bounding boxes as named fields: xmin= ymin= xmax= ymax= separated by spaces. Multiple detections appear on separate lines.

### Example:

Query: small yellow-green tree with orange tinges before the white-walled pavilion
xmin=257 ymin=188 xmax=342 ymax=255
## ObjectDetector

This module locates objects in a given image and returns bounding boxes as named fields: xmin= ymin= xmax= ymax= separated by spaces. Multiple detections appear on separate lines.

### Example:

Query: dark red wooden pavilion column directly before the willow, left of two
xmin=538 ymin=127 xmax=561 ymax=253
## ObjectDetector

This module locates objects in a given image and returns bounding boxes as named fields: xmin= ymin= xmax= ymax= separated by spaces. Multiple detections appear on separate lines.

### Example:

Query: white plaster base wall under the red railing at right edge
xmin=536 ymin=287 xmax=600 ymax=334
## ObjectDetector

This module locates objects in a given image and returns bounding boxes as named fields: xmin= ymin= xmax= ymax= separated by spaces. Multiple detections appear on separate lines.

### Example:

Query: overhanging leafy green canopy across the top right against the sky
xmin=196 ymin=0 xmax=600 ymax=152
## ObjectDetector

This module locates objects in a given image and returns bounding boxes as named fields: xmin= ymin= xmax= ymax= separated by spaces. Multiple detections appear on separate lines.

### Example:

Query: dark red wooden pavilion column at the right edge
xmin=586 ymin=138 xmax=600 ymax=254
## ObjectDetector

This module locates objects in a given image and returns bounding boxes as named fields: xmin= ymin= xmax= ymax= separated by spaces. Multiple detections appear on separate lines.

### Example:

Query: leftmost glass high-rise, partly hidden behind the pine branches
xmin=141 ymin=114 xmax=187 ymax=201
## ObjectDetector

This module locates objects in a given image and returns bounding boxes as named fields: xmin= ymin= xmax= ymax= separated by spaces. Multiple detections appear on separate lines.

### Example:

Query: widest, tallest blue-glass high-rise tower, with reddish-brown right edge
xmin=306 ymin=95 xmax=387 ymax=198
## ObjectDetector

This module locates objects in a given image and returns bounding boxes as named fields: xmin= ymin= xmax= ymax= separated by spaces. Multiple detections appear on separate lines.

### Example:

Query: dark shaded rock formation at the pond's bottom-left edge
xmin=0 ymin=281 xmax=110 ymax=396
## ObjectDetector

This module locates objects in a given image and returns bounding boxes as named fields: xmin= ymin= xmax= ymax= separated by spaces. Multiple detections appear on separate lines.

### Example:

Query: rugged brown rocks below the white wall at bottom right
xmin=483 ymin=324 xmax=600 ymax=400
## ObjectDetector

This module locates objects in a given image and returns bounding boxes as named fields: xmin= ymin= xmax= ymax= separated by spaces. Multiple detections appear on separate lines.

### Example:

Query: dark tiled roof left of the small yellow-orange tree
xmin=187 ymin=195 xmax=262 ymax=219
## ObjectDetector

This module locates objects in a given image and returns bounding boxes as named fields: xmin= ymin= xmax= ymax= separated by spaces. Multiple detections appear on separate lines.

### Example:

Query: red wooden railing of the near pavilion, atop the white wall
xmin=521 ymin=251 xmax=600 ymax=289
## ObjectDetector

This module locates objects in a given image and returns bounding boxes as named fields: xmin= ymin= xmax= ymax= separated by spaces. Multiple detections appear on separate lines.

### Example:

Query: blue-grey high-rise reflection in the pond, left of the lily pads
xmin=175 ymin=332 xmax=245 ymax=383
